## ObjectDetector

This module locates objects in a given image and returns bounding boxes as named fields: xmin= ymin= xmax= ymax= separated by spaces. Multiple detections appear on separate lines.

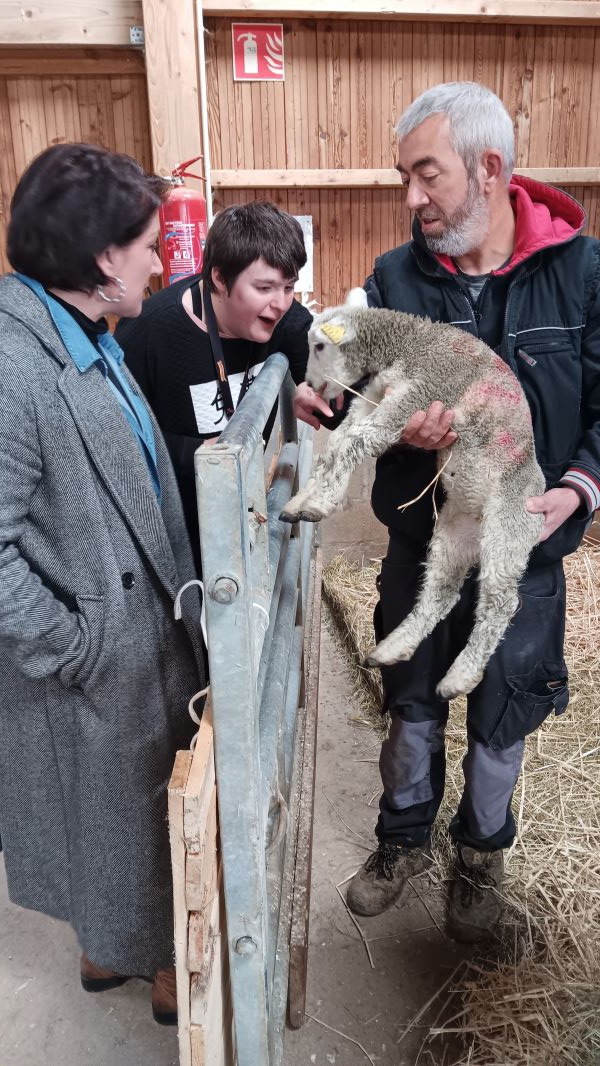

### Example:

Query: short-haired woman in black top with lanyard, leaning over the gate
xmin=116 ymin=200 xmax=312 ymax=570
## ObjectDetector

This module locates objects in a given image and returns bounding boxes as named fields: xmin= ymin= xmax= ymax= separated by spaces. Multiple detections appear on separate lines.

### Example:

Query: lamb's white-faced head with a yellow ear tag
xmin=306 ymin=289 xmax=368 ymax=400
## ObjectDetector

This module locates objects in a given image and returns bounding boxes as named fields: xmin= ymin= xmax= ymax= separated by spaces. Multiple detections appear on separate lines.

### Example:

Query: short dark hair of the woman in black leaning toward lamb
xmin=202 ymin=200 xmax=306 ymax=292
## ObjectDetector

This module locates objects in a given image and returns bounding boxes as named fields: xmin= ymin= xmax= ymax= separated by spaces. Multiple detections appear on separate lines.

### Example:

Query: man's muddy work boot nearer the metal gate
xmin=346 ymin=841 xmax=432 ymax=917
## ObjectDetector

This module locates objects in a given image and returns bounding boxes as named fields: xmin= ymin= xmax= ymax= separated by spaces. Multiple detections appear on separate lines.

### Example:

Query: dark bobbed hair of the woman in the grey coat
xmin=6 ymin=144 xmax=171 ymax=292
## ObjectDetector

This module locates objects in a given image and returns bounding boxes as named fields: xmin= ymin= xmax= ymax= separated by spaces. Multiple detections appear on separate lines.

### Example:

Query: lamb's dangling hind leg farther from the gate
xmin=437 ymin=499 xmax=544 ymax=699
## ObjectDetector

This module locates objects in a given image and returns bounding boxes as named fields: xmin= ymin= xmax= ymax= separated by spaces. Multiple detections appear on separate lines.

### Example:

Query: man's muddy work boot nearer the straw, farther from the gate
xmin=448 ymin=844 xmax=504 ymax=943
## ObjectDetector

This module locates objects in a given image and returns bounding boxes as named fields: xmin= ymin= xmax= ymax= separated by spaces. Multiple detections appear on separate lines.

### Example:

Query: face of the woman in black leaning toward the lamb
xmin=212 ymin=259 xmax=297 ymax=344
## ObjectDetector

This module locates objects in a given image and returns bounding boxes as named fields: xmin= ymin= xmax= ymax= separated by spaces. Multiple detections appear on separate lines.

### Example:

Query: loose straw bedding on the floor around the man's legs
xmin=324 ymin=540 xmax=600 ymax=1066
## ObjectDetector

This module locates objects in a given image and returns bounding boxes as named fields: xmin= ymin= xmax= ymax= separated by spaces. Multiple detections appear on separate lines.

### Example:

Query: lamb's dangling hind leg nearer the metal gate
xmin=364 ymin=500 xmax=481 ymax=666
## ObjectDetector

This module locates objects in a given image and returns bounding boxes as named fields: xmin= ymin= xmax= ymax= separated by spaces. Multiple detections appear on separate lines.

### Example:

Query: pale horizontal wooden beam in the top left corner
xmin=0 ymin=0 xmax=142 ymax=45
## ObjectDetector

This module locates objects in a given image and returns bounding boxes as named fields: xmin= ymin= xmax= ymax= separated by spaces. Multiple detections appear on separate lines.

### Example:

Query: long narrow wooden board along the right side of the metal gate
xmin=288 ymin=549 xmax=323 ymax=1029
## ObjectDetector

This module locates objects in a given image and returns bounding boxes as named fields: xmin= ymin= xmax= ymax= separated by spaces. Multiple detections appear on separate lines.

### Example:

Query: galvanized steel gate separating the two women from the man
xmin=195 ymin=354 xmax=313 ymax=1066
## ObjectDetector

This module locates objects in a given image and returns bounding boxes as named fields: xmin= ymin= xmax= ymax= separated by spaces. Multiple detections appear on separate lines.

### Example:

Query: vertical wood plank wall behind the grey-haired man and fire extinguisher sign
xmin=206 ymin=19 xmax=600 ymax=304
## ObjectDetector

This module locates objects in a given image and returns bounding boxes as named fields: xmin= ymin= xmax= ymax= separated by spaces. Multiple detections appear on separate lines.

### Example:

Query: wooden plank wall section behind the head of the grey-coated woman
xmin=0 ymin=46 xmax=151 ymax=272
